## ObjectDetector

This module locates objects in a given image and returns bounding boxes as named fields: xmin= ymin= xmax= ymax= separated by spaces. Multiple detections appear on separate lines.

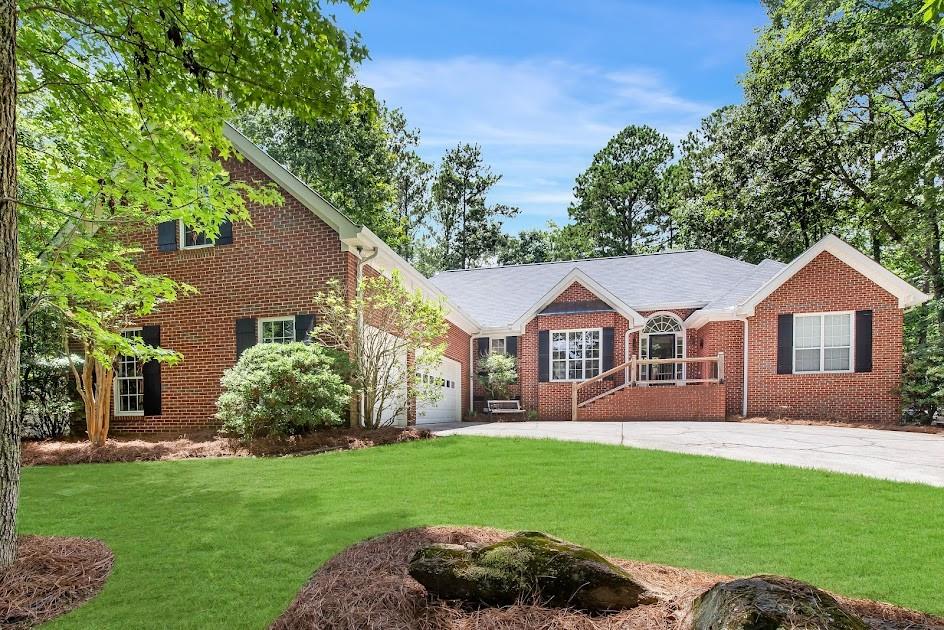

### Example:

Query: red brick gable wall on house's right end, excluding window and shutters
xmin=748 ymin=252 xmax=902 ymax=422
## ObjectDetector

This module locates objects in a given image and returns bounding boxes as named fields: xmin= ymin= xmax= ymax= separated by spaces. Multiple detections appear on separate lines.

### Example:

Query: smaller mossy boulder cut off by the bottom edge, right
xmin=691 ymin=575 xmax=869 ymax=630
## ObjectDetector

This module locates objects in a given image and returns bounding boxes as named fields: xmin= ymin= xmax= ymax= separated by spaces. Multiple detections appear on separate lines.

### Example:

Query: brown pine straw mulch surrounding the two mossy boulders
xmin=272 ymin=527 xmax=944 ymax=630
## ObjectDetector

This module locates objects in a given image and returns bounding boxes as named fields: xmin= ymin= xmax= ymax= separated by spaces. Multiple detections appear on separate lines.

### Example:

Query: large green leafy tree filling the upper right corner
xmin=744 ymin=0 xmax=944 ymax=336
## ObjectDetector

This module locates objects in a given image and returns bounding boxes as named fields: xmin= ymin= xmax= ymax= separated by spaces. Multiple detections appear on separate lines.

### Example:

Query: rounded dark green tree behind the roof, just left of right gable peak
xmin=668 ymin=102 xmax=845 ymax=262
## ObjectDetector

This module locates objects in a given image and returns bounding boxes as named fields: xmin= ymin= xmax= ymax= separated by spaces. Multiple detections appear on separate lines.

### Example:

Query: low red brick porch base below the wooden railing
xmin=577 ymin=383 xmax=726 ymax=421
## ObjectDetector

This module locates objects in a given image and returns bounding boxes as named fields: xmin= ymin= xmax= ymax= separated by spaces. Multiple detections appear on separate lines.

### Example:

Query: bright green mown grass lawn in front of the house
xmin=20 ymin=437 xmax=944 ymax=628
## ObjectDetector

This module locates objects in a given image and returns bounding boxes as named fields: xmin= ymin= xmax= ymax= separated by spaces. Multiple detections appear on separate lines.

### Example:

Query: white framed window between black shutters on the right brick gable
xmin=793 ymin=311 xmax=855 ymax=374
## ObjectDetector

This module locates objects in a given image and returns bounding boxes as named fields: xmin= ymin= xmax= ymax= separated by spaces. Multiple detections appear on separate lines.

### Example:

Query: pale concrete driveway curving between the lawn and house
xmin=430 ymin=422 xmax=944 ymax=487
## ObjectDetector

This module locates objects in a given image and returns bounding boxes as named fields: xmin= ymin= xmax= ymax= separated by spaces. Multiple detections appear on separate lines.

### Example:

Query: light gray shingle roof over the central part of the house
xmin=431 ymin=249 xmax=784 ymax=327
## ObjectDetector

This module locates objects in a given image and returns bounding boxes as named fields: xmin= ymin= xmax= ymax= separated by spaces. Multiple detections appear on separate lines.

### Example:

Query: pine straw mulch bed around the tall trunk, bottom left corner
xmin=0 ymin=536 xmax=114 ymax=628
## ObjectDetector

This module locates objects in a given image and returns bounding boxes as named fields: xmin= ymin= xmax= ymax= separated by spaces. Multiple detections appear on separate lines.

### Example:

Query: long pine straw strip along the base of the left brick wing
xmin=22 ymin=427 xmax=432 ymax=466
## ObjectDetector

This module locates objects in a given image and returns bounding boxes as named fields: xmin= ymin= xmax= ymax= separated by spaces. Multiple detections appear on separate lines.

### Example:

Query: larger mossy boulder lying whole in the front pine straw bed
xmin=409 ymin=532 xmax=654 ymax=611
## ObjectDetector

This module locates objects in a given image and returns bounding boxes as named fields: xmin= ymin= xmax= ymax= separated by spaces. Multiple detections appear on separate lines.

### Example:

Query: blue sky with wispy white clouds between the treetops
xmin=338 ymin=0 xmax=765 ymax=231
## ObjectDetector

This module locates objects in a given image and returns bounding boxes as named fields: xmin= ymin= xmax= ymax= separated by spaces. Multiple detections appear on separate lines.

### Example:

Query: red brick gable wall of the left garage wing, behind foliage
xmin=112 ymin=160 xmax=356 ymax=432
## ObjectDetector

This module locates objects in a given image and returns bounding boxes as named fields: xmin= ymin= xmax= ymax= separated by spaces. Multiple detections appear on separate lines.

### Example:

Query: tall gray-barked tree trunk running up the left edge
xmin=0 ymin=0 xmax=20 ymax=569
